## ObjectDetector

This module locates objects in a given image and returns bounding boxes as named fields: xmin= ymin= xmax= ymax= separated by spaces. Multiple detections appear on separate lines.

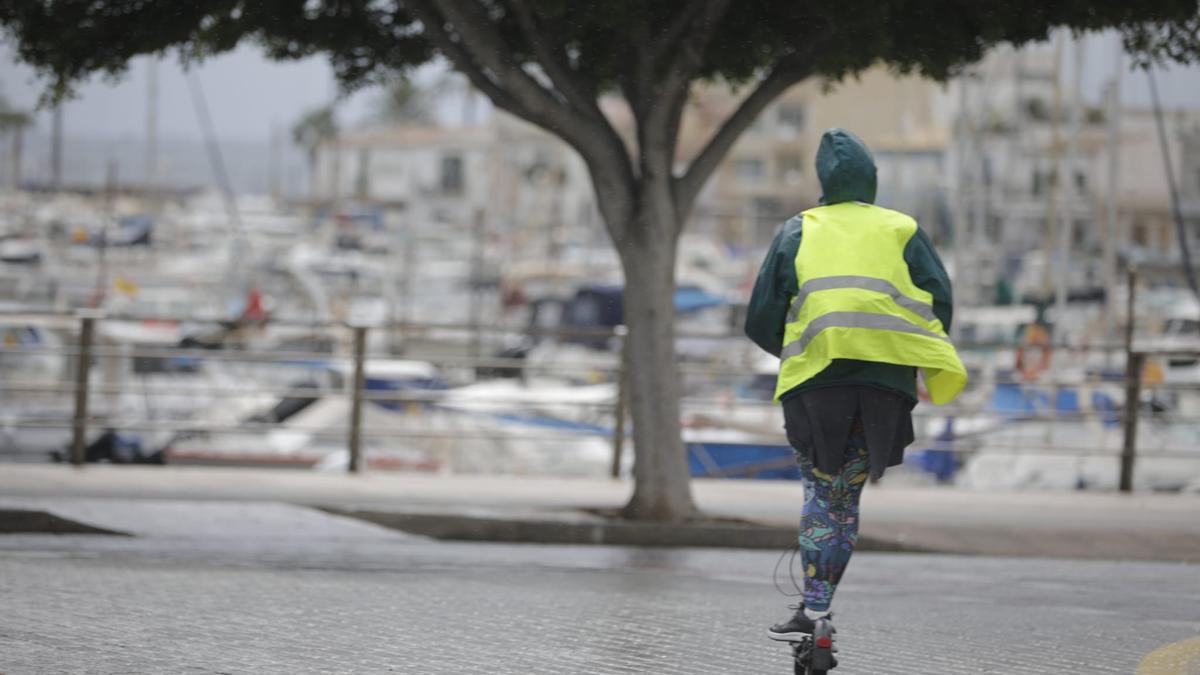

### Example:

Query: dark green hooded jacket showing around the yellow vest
xmin=745 ymin=129 xmax=953 ymax=402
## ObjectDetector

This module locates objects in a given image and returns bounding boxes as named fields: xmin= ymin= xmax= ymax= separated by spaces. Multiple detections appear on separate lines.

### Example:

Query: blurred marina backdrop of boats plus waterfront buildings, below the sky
xmin=0 ymin=35 xmax=1200 ymax=491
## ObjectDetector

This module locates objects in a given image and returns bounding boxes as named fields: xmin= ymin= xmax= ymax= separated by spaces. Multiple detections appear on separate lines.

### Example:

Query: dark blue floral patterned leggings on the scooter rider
xmin=797 ymin=434 xmax=869 ymax=611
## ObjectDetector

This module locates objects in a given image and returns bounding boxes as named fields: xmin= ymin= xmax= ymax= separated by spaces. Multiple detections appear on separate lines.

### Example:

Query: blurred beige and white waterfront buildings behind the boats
xmin=317 ymin=46 xmax=1200 ymax=304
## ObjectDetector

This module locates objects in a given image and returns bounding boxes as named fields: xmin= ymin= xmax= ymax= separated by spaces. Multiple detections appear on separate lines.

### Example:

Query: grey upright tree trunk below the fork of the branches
xmin=618 ymin=180 xmax=696 ymax=521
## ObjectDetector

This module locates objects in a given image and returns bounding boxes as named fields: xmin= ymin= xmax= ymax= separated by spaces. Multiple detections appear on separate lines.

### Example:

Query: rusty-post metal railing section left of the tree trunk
xmin=0 ymin=312 xmax=643 ymax=472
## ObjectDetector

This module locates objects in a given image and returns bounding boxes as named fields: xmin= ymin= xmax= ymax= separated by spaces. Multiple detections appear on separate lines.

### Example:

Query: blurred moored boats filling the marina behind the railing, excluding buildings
xmin=0 ymin=183 xmax=1200 ymax=491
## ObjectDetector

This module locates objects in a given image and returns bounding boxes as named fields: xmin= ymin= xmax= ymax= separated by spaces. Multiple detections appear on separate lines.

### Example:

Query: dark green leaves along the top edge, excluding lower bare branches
xmin=7 ymin=0 xmax=1200 ymax=91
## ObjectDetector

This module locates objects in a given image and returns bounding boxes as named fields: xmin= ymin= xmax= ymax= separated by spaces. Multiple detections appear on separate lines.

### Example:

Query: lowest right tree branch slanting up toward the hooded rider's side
xmin=676 ymin=62 xmax=809 ymax=213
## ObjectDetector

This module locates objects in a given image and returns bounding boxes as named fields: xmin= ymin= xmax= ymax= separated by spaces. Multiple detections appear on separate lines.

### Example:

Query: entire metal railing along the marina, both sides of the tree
xmin=0 ymin=282 xmax=1200 ymax=491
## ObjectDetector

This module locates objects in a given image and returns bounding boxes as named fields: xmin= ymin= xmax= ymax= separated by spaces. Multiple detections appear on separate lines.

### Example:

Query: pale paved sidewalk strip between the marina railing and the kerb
xmin=0 ymin=465 xmax=1200 ymax=562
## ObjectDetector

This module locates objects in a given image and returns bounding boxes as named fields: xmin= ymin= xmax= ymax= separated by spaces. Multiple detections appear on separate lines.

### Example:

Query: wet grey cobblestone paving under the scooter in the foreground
xmin=0 ymin=506 xmax=1200 ymax=675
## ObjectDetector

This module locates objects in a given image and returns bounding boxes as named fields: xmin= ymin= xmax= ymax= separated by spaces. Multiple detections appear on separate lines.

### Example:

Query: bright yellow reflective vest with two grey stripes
xmin=775 ymin=202 xmax=967 ymax=404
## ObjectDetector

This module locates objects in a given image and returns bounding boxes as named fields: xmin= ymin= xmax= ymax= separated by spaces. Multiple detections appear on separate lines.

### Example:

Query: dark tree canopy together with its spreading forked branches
xmin=0 ymin=0 xmax=1200 ymax=230
